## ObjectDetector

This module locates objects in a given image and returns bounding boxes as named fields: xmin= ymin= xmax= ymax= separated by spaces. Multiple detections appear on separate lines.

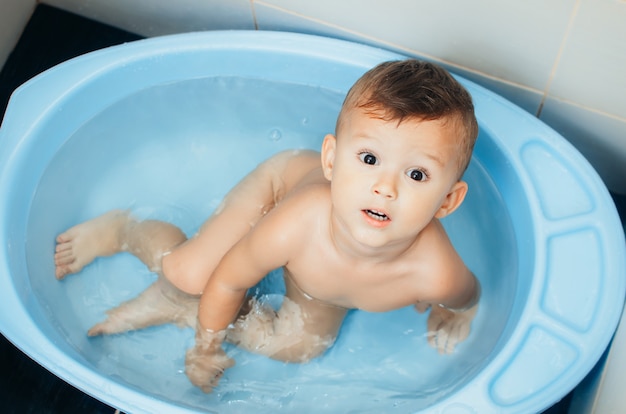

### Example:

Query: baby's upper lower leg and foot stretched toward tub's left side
xmin=54 ymin=210 xmax=186 ymax=279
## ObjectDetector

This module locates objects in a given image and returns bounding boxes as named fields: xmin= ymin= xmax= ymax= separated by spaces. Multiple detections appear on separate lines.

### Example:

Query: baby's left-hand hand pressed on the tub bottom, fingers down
xmin=185 ymin=327 xmax=235 ymax=393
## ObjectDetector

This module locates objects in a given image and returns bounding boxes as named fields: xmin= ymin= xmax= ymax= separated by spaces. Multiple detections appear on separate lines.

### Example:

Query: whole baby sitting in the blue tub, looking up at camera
xmin=55 ymin=60 xmax=480 ymax=392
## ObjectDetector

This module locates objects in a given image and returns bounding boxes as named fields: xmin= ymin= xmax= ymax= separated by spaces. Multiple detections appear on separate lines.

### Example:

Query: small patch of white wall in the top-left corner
xmin=0 ymin=0 xmax=36 ymax=68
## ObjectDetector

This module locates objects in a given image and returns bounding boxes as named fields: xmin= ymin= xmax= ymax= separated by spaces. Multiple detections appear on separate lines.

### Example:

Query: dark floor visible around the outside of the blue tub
xmin=0 ymin=5 xmax=626 ymax=414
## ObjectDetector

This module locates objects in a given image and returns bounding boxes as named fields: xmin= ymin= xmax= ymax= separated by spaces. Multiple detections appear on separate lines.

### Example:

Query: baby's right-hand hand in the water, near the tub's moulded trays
xmin=418 ymin=305 xmax=478 ymax=354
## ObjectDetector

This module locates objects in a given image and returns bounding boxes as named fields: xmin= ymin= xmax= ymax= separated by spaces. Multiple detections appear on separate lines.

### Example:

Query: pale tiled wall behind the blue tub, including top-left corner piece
xmin=0 ymin=0 xmax=626 ymax=194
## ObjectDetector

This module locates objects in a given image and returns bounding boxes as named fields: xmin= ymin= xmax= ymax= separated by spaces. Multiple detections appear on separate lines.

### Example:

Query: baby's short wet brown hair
xmin=336 ymin=59 xmax=478 ymax=178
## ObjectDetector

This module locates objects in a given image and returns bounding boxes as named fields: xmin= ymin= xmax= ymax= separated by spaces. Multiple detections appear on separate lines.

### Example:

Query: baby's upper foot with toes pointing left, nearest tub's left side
xmin=54 ymin=210 xmax=130 ymax=279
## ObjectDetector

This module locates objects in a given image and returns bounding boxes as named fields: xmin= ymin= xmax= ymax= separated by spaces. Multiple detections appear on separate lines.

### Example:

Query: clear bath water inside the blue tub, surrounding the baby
xmin=27 ymin=77 xmax=517 ymax=413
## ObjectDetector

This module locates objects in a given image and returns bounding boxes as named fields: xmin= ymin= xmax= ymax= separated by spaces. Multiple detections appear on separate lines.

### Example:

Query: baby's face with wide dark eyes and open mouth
xmin=323 ymin=109 xmax=465 ymax=247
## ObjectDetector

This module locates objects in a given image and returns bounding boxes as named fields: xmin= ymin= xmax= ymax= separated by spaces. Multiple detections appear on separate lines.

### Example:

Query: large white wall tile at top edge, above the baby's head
xmin=255 ymin=0 xmax=576 ymax=90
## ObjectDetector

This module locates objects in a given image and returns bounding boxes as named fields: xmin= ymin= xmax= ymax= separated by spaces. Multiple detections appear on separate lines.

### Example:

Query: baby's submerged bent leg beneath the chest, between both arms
xmin=226 ymin=276 xmax=347 ymax=362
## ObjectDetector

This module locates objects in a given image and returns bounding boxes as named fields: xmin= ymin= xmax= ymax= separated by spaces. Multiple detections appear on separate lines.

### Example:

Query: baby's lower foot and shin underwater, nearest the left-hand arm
xmin=87 ymin=278 xmax=199 ymax=336
